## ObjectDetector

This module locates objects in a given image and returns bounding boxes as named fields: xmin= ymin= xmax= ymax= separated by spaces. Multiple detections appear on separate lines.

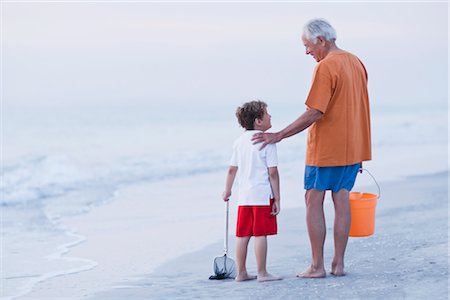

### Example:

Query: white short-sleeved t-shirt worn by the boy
xmin=230 ymin=130 xmax=278 ymax=206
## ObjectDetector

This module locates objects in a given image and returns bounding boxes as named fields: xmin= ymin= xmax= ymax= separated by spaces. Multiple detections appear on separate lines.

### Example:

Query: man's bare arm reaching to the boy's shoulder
xmin=252 ymin=108 xmax=323 ymax=149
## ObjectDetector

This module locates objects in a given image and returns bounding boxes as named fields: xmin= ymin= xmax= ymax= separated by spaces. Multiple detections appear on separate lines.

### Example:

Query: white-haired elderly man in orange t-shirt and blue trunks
xmin=253 ymin=19 xmax=372 ymax=278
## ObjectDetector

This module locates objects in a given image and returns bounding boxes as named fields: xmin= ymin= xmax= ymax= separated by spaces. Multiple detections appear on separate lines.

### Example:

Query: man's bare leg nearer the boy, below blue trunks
xmin=297 ymin=189 xmax=326 ymax=278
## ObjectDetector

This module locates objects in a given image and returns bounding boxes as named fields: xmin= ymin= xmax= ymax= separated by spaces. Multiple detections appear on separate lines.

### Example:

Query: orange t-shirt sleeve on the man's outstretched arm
xmin=305 ymin=64 xmax=333 ymax=113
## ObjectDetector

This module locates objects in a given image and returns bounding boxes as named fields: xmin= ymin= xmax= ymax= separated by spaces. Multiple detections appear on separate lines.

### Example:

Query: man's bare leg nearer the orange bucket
xmin=331 ymin=189 xmax=351 ymax=276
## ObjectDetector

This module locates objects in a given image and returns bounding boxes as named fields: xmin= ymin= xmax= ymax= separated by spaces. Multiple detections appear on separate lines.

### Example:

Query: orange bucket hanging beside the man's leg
xmin=349 ymin=192 xmax=378 ymax=237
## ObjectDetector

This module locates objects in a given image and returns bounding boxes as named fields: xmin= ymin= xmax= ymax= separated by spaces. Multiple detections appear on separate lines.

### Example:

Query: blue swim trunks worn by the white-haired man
xmin=305 ymin=163 xmax=360 ymax=193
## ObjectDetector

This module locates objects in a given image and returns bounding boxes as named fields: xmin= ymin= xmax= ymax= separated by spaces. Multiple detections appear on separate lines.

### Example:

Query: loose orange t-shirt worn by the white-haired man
xmin=306 ymin=52 xmax=372 ymax=167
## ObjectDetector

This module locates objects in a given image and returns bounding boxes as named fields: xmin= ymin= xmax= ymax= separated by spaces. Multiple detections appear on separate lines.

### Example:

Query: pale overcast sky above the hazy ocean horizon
xmin=1 ymin=1 xmax=448 ymax=105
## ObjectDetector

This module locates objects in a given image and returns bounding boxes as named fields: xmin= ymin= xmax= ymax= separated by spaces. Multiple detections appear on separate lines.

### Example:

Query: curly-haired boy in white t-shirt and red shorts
xmin=223 ymin=101 xmax=281 ymax=281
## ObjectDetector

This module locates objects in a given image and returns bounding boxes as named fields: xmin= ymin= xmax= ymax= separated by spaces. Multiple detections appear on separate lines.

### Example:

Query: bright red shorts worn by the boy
xmin=236 ymin=200 xmax=277 ymax=237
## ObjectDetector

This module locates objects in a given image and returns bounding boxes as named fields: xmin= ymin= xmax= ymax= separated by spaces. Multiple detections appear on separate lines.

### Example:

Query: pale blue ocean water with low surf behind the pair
xmin=0 ymin=101 xmax=448 ymax=299
